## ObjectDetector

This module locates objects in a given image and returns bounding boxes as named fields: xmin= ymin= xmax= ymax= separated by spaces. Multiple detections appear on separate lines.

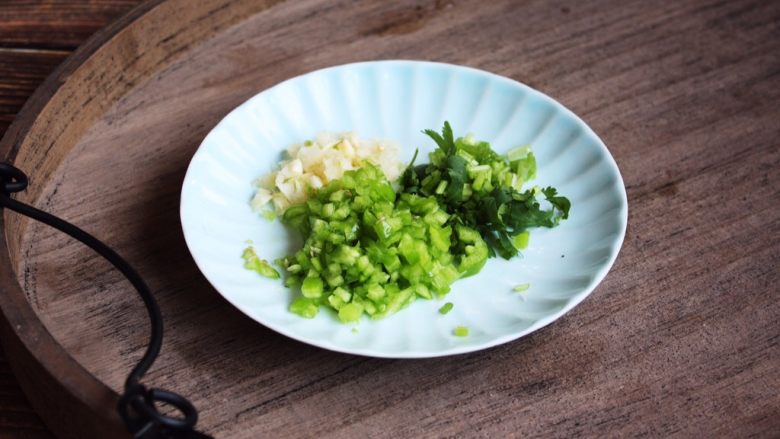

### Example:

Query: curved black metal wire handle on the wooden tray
xmin=0 ymin=162 xmax=210 ymax=439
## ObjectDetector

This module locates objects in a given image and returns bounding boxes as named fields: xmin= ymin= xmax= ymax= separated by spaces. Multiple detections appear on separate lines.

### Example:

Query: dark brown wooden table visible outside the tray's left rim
xmin=0 ymin=0 xmax=140 ymax=439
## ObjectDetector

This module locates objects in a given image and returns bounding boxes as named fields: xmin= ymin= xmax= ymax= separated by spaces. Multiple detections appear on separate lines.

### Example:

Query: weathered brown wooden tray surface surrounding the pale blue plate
xmin=2 ymin=0 xmax=780 ymax=438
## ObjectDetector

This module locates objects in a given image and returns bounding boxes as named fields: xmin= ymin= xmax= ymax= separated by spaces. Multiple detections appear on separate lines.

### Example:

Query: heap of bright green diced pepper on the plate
xmin=280 ymin=164 xmax=466 ymax=323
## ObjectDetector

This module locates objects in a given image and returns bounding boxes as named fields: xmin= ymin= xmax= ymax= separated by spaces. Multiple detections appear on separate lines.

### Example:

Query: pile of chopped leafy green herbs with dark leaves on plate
xmin=401 ymin=122 xmax=571 ymax=259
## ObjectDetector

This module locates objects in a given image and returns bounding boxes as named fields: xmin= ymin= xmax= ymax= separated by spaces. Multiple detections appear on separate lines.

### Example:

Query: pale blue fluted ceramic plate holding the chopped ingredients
xmin=181 ymin=61 xmax=628 ymax=358
